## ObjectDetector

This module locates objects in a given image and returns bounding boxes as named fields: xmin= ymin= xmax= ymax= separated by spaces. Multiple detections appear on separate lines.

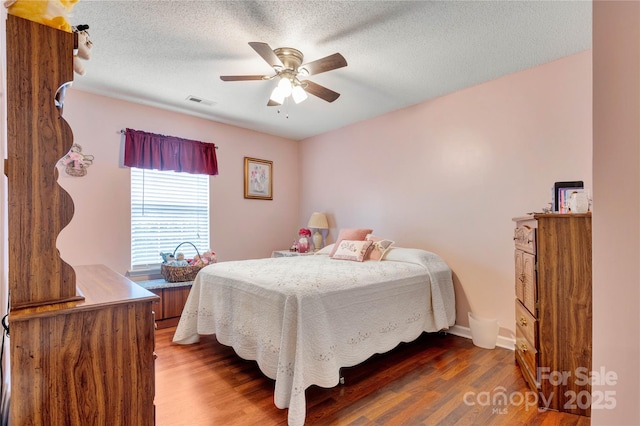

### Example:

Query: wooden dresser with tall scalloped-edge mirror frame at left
xmin=5 ymin=15 xmax=158 ymax=426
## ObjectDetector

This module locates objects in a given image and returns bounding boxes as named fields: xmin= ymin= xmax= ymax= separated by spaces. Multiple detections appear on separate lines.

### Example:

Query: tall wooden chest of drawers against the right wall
xmin=513 ymin=213 xmax=592 ymax=416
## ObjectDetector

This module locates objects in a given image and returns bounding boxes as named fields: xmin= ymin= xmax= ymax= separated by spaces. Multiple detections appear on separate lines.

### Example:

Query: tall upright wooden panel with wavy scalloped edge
xmin=6 ymin=15 xmax=77 ymax=307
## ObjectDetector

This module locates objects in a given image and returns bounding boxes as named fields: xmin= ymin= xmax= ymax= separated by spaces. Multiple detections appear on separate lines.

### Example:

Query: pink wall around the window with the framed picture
xmin=58 ymin=88 xmax=300 ymax=273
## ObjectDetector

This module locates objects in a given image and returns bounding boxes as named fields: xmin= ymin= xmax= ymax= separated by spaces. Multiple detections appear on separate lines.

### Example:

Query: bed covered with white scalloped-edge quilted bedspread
xmin=173 ymin=247 xmax=455 ymax=426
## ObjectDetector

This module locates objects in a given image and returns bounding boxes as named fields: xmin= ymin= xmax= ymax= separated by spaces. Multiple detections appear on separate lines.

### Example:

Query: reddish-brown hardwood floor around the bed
xmin=155 ymin=327 xmax=590 ymax=426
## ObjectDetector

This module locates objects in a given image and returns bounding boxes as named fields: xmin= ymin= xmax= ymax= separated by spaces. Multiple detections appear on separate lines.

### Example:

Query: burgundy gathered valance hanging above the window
xmin=124 ymin=129 xmax=218 ymax=175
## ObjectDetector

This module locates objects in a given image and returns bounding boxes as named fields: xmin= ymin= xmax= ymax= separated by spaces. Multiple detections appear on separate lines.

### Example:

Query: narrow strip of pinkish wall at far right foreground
xmin=591 ymin=1 xmax=640 ymax=425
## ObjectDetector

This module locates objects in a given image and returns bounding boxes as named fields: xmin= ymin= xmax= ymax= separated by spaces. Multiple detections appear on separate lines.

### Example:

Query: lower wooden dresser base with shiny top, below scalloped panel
xmin=10 ymin=265 xmax=157 ymax=426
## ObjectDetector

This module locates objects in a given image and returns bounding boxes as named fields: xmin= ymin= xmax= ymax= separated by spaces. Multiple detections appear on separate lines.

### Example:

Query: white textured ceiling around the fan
xmin=70 ymin=0 xmax=591 ymax=140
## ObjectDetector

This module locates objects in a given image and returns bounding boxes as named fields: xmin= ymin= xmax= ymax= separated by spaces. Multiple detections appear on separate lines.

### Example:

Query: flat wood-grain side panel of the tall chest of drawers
xmin=537 ymin=214 xmax=592 ymax=415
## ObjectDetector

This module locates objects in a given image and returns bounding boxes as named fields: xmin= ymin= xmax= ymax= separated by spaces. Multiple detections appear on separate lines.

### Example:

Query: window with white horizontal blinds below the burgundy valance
xmin=131 ymin=167 xmax=210 ymax=271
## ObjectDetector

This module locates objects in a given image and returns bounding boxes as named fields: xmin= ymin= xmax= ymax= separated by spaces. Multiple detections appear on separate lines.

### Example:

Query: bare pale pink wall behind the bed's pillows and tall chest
xmin=300 ymin=51 xmax=592 ymax=336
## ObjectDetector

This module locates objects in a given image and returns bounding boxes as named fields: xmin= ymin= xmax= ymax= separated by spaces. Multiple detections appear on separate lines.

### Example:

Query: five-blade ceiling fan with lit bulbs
xmin=220 ymin=42 xmax=347 ymax=106
